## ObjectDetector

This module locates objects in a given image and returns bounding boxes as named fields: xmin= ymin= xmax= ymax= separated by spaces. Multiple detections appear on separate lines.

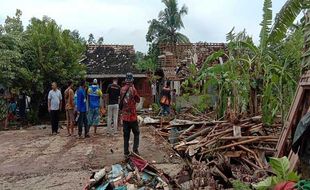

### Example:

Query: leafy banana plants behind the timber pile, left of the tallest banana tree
xmin=193 ymin=30 xmax=254 ymax=118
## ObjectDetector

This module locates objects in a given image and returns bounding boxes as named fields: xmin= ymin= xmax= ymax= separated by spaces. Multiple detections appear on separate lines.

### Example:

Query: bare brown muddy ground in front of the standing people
xmin=0 ymin=127 xmax=184 ymax=190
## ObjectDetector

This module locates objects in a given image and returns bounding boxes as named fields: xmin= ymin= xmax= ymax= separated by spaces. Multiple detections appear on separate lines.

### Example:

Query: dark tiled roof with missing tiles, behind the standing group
xmin=81 ymin=45 xmax=146 ymax=78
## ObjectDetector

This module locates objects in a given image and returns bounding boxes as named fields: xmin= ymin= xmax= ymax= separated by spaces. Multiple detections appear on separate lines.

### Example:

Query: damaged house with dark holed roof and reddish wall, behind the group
xmin=82 ymin=45 xmax=152 ymax=107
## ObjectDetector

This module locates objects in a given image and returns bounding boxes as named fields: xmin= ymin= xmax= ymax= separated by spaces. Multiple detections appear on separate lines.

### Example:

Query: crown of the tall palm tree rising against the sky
xmin=146 ymin=0 xmax=189 ymax=44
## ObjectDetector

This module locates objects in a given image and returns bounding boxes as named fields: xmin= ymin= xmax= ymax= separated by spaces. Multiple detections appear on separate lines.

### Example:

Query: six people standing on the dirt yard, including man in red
xmin=48 ymin=73 xmax=140 ymax=156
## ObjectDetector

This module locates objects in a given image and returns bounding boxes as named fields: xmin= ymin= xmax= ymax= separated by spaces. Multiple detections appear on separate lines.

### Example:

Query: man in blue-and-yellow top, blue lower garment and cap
xmin=87 ymin=79 xmax=102 ymax=134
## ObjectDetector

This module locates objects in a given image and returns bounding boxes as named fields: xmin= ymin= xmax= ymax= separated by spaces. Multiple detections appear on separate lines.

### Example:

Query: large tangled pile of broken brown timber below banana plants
xmin=156 ymin=116 xmax=282 ymax=189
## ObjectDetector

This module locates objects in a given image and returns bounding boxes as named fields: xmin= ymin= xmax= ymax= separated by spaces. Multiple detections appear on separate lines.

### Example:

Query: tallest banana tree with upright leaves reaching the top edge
xmin=242 ymin=0 xmax=303 ymax=123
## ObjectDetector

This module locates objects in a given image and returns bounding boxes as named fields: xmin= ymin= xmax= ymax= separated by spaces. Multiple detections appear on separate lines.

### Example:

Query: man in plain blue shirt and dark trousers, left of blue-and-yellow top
xmin=76 ymin=80 xmax=89 ymax=138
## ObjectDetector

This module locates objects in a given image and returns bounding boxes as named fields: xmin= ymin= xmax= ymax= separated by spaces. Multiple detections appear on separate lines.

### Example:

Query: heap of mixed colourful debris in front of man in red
xmin=84 ymin=154 xmax=179 ymax=190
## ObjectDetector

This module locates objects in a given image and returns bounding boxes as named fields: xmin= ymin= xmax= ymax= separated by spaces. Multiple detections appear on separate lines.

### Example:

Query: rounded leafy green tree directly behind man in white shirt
xmin=19 ymin=16 xmax=86 ymax=121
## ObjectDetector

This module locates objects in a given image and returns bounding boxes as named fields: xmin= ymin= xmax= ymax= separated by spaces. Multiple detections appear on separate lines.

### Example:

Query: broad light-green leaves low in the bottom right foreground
xmin=253 ymin=157 xmax=300 ymax=190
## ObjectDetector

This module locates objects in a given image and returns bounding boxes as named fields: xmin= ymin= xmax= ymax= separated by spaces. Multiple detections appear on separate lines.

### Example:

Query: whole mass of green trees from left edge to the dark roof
xmin=0 ymin=10 xmax=86 ymax=121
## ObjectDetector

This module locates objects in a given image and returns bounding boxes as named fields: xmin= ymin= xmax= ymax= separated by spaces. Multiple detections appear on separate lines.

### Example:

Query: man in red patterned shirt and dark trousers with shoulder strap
xmin=120 ymin=73 xmax=140 ymax=157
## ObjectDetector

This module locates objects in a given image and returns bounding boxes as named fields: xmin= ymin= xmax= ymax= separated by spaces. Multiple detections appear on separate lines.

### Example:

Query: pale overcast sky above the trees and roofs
xmin=0 ymin=0 xmax=286 ymax=52
